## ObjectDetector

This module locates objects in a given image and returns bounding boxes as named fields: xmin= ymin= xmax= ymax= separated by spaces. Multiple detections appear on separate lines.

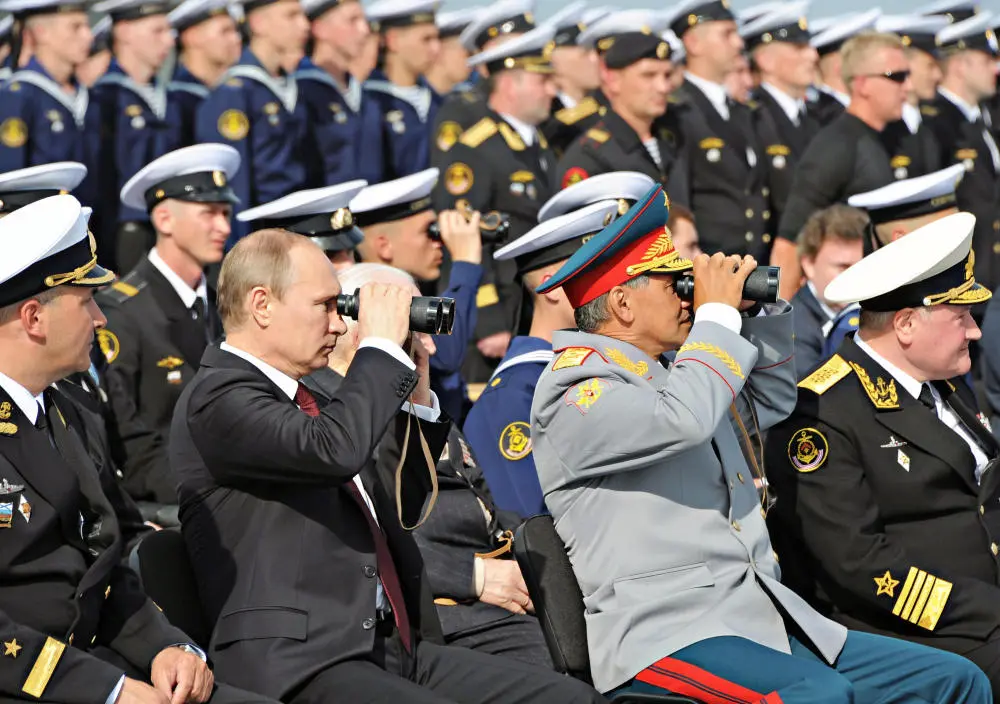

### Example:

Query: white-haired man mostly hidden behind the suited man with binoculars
xmin=303 ymin=264 xmax=551 ymax=665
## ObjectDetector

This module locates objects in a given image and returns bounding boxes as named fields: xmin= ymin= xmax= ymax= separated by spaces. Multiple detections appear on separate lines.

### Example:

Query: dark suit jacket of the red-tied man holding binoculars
xmin=170 ymin=346 xmax=449 ymax=699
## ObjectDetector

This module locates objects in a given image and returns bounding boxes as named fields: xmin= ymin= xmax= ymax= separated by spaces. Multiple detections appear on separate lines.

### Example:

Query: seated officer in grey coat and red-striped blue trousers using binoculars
xmin=531 ymin=183 xmax=989 ymax=704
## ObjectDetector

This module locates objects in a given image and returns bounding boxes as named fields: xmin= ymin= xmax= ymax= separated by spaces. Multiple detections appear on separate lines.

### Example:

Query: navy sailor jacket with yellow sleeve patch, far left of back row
xmin=0 ymin=58 xmax=100 ymax=205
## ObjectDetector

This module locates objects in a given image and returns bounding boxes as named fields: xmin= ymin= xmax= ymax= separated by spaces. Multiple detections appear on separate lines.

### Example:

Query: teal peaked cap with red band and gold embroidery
xmin=536 ymin=185 xmax=691 ymax=308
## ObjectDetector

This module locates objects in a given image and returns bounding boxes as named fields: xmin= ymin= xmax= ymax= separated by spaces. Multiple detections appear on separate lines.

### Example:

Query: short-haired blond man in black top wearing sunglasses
xmin=771 ymin=32 xmax=910 ymax=300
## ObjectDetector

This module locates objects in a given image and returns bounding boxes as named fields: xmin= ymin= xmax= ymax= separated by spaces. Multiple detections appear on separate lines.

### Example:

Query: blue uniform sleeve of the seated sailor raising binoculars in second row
xmin=430 ymin=262 xmax=483 ymax=422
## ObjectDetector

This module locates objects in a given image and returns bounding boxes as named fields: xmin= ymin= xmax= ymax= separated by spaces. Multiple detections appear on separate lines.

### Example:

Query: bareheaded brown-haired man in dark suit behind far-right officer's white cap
xmin=791 ymin=204 xmax=868 ymax=379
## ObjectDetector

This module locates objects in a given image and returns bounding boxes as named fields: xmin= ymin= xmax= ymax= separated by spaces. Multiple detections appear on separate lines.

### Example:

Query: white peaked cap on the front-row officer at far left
xmin=0 ymin=195 xmax=115 ymax=306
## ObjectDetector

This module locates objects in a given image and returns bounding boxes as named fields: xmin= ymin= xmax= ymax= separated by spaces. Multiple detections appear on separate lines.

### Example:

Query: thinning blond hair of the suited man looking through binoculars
xmin=216 ymin=228 xmax=306 ymax=333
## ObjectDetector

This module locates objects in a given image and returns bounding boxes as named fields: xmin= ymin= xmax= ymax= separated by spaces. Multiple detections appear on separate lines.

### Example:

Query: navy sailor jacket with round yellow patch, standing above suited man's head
xmin=195 ymin=49 xmax=312 ymax=247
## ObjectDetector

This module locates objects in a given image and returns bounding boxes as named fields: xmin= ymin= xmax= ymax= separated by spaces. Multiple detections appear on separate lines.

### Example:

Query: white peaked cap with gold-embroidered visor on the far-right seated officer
xmin=823 ymin=213 xmax=992 ymax=312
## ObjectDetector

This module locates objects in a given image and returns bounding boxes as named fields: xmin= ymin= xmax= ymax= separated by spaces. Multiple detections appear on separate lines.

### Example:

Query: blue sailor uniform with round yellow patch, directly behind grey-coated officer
xmin=462 ymin=335 xmax=553 ymax=516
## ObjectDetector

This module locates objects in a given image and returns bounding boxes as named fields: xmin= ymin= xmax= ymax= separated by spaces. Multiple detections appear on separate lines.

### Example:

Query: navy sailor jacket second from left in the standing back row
xmin=89 ymin=59 xmax=185 ymax=226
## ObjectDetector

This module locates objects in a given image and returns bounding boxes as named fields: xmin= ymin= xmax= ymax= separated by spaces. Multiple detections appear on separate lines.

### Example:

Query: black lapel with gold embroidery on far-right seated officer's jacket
xmin=839 ymin=337 xmax=979 ymax=494
